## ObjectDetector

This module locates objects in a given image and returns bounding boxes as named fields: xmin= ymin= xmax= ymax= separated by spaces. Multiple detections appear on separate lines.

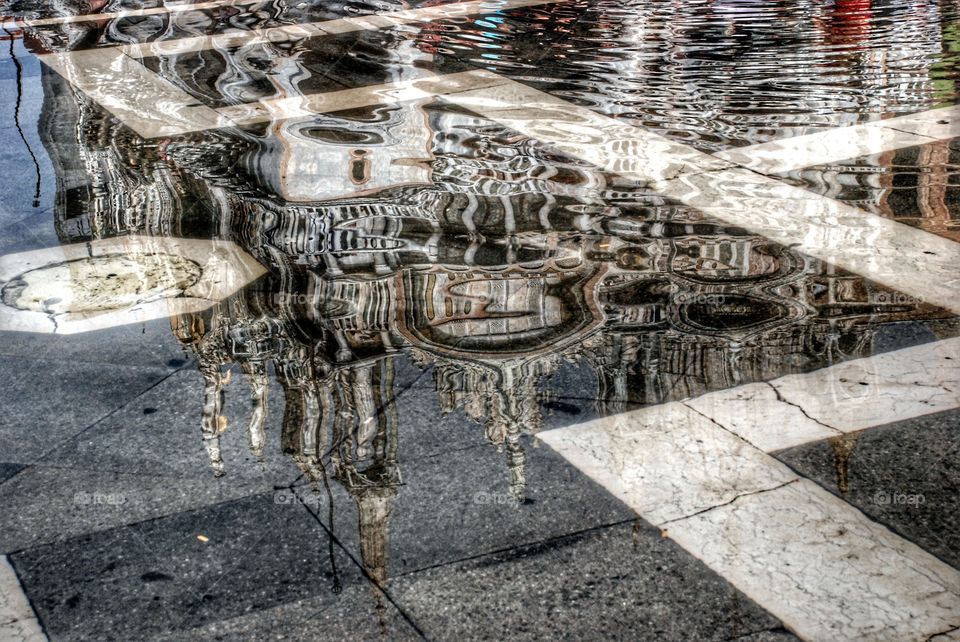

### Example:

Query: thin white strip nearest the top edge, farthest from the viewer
xmin=113 ymin=0 xmax=565 ymax=58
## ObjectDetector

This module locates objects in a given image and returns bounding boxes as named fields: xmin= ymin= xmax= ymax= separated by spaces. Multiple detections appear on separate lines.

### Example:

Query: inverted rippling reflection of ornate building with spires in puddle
xmin=26 ymin=0 xmax=956 ymax=583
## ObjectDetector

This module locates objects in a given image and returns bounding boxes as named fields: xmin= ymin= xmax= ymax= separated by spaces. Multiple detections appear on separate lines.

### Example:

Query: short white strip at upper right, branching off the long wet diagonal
xmin=714 ymin=107 xmax=960 ymax=174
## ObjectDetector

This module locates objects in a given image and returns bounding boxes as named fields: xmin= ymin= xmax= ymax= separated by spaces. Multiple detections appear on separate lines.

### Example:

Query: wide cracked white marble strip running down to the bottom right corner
xmin=538 ymin=370 xmax=960 ymax=642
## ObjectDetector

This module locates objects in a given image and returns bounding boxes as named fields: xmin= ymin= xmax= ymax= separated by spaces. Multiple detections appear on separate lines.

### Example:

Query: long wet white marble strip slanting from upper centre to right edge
xmin=438 ymin=72 xmax=960 ymax=314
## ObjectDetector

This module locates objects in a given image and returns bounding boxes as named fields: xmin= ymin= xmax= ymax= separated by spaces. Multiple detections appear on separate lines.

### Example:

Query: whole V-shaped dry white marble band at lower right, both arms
xmin=538 ymin=339 xmax=960 ymax=641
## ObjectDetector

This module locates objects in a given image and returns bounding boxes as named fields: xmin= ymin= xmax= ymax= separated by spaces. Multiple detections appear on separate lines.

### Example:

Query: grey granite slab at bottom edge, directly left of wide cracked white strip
xmin=390 ymin=521 xmax=791 ymax=640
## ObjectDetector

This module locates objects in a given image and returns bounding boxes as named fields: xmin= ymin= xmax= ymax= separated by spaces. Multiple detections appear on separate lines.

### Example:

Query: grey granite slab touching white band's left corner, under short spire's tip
xmin=290 ymin=430 xmax=634 ymax=577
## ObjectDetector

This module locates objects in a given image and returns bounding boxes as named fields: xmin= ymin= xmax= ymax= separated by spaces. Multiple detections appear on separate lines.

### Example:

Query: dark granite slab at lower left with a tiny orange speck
xmin=11 ymin=494 xmax=393 ymax=640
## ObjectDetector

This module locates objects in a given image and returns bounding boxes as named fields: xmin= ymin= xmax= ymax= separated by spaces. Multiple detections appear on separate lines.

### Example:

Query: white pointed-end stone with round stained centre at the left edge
xmin=0 ymin=236 xmax=266 ymax=334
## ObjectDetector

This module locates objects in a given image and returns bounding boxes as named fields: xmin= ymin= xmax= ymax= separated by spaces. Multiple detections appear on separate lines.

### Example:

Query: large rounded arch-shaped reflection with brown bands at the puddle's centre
xmin=398 ymin=269 xmax=603 ymax=357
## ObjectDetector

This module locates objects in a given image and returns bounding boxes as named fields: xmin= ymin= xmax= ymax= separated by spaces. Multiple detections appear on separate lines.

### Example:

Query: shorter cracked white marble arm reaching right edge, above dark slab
xmin=688 ymin=338 xmax=960 ymax=452
